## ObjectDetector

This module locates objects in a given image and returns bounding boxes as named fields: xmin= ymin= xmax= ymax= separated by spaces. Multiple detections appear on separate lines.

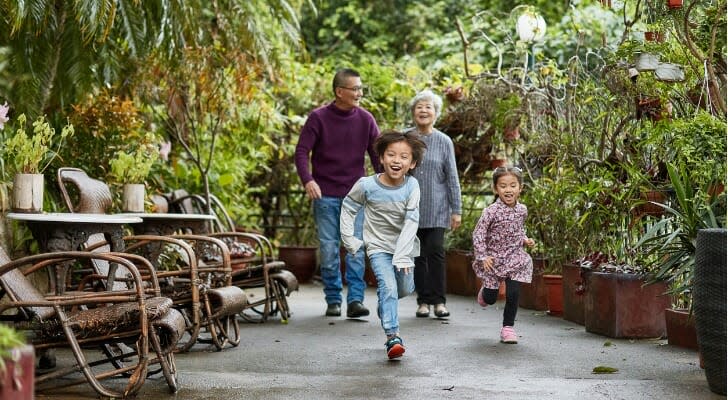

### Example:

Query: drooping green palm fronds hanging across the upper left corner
xmin=0 ymin=0 xmax=313 ymax=119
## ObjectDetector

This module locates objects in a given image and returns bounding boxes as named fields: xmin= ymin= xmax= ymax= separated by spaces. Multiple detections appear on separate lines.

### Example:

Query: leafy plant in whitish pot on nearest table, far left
xmin=5 ymin=114 xmax=73 ymax=212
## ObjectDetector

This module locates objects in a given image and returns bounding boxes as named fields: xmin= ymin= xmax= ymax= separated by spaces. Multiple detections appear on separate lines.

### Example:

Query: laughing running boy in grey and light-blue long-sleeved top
xmin=340 ymin=131 xmax=426 ymax=359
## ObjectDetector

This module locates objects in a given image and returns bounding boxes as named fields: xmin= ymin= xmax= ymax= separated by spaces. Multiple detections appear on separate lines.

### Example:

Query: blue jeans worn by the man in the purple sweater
xmin=313 ymin=196 xmax=366 ymax=304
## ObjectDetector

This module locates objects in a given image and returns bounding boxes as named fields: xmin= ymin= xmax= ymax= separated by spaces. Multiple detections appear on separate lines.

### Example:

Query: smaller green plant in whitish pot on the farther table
xmin=109 ymin=133 xmax=159 ymax=212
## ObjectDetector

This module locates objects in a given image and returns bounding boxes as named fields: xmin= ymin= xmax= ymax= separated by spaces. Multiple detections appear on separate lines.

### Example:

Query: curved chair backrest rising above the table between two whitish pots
xmin=58 ymin=167 xmax=113 ymax=214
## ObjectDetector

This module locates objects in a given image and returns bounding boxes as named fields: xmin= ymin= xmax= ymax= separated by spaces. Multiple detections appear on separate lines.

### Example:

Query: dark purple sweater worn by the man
xmin=295 ymin=102 xmax=381 ymax=197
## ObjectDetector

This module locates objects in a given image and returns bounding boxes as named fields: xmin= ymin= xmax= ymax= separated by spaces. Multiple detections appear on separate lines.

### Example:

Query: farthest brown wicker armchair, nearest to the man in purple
xmin=166 ymin=190 xmax=298 ymax=322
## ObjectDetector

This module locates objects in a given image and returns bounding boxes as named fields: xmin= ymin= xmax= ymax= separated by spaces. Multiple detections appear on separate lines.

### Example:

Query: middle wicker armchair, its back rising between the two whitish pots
xmin=58 ymin=168 xmax=247 ymax=351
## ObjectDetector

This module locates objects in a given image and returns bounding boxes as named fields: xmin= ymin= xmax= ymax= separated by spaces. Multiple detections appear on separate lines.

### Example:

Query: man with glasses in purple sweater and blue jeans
xmin=295 ymin=69 xmax=380 ymax=318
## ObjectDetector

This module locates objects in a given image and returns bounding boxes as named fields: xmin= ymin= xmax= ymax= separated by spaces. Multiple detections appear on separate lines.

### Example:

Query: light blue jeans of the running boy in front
xmin=369 ymin=253 xmax=415 ymax=336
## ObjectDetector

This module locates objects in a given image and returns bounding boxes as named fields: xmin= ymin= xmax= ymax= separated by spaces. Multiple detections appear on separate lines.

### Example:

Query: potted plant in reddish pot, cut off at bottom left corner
xmin=0 ymin=324 xmax=35 ymax=400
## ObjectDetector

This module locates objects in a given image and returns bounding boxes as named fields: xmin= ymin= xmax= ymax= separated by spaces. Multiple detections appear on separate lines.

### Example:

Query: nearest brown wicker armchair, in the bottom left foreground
xmin=0 ymin=248 xmax=185 ymax=397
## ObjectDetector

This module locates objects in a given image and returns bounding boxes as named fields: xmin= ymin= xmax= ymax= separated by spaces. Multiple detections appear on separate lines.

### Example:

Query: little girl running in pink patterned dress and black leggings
xmin=473 ymin=167 xmax=534 ymax=343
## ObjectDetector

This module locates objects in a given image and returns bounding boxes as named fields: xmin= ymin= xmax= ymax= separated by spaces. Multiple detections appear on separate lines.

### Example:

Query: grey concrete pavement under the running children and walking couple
xmin=36 ymin=283 xmax=724 ymax=400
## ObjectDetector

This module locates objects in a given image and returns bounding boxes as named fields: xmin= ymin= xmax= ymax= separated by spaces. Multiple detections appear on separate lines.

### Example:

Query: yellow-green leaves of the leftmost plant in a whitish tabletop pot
xmin=5 ymin=114 xmax=74 ymax=174
